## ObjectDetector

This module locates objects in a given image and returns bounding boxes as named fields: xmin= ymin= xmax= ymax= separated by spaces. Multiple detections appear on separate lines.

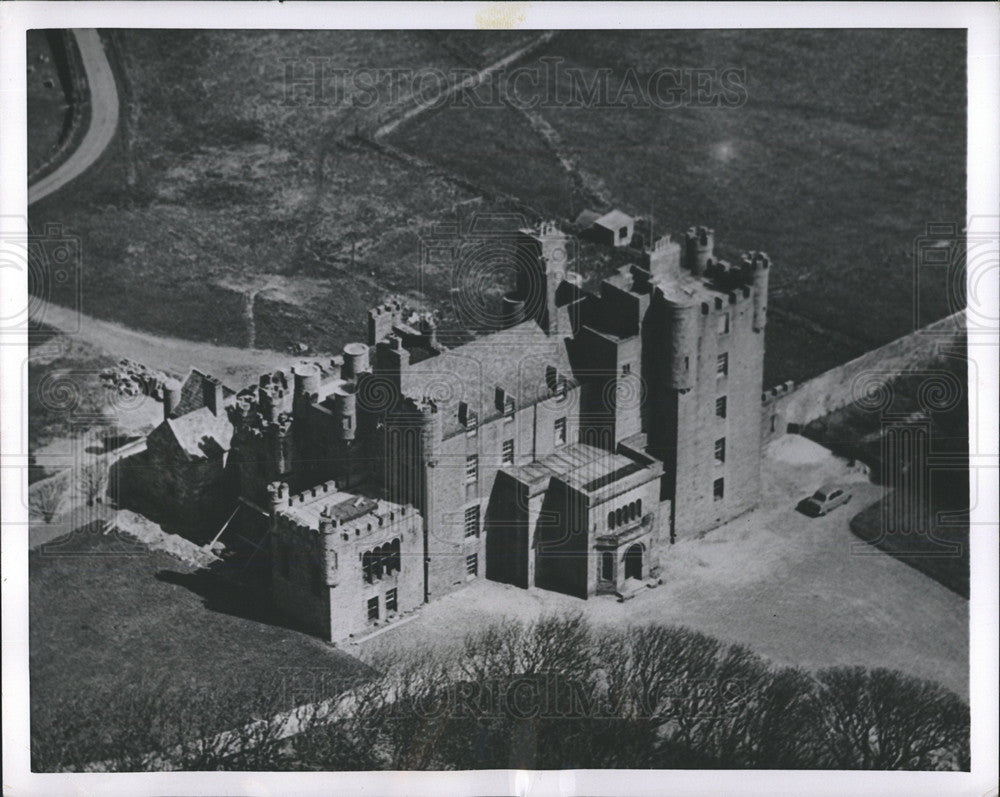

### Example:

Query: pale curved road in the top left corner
xmin=28 ymin=28 xmax=118 ymax=205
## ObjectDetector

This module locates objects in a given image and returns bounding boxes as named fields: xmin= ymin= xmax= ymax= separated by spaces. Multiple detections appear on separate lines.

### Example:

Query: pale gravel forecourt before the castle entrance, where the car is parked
xmin=364 ymin=435 xmax=969 ymax=699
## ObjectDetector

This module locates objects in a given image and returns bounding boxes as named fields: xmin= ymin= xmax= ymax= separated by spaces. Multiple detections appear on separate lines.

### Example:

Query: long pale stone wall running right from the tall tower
xmin=761 ymin=310 xmax=965 ymax=443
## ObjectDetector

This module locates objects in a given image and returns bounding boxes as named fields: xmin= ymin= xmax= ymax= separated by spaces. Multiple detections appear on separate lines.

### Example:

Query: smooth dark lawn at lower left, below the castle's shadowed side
xmin=29 ymin=529 xmax=363 ymax=766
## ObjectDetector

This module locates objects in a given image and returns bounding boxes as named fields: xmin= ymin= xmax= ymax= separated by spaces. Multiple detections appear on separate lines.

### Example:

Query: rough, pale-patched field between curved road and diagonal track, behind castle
xmin=29 ymin=30 xmax=482 ymax=351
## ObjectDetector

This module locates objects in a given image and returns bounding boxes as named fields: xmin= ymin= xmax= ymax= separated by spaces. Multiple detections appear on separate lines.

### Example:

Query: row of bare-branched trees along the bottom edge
xmin=32 ymin=614 xmax=970 ymax=771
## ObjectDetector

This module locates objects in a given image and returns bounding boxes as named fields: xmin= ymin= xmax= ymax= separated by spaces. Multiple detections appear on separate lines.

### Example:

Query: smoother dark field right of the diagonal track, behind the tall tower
xmin=395 ymin=30 xmax=966 ymax=384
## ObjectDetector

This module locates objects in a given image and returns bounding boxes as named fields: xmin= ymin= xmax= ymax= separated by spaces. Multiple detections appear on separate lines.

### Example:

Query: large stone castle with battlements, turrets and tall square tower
xmin=121 ymin=218 xmax=773 ymax=641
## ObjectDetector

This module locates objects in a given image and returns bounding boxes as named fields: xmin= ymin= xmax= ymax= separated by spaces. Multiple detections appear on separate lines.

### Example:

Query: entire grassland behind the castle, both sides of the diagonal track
xmin=31 ymin=30 xmax=965 ymax=383
